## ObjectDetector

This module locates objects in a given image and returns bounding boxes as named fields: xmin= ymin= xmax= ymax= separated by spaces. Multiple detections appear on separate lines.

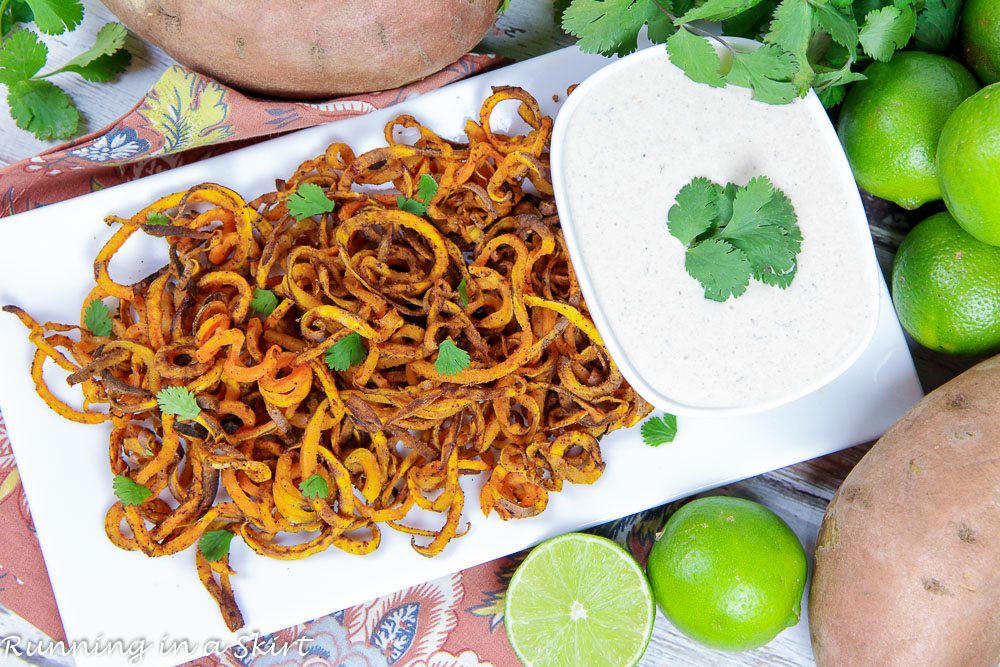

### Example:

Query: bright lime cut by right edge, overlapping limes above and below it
xmin=937 ymin=83 xmax=1000 ymax=245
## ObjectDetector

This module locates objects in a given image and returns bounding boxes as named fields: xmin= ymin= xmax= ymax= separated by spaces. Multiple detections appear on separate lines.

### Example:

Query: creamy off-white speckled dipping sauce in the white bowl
xmin=557 ymin=47 xmax=879 ymax=408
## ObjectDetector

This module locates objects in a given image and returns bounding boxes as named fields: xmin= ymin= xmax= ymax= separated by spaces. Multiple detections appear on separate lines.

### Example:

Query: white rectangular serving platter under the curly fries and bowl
xmin=0 ymin=48 xmax=921 ymax=667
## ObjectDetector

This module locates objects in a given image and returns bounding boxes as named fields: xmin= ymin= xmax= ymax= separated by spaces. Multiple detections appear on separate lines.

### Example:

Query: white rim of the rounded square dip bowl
xmin=550 ymin=37 xmax=881 ymax=416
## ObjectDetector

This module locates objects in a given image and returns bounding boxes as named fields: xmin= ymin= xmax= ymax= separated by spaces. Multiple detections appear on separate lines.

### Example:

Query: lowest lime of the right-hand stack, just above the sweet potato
xmin=892 ymin=213 xmax=1000 ymax=355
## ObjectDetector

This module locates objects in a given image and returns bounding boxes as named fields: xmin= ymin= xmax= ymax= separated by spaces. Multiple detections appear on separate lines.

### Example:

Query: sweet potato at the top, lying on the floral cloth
xmin=103 ymin=0 xmax=498 ymax=99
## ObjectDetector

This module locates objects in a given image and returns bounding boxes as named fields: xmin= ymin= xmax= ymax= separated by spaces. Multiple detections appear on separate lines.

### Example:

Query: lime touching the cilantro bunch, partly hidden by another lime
xmin=837 ymin=51 xmax=979 ymax=208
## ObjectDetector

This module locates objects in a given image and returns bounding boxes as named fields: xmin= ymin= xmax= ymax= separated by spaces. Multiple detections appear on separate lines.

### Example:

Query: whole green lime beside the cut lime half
xmin=646 ymin=496 xmax=807 ymax=651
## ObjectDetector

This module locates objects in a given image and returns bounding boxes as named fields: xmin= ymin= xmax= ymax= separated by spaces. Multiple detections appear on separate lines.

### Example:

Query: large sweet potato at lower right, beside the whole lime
xmin=809 ymin=356 xmax=1000 ymax=667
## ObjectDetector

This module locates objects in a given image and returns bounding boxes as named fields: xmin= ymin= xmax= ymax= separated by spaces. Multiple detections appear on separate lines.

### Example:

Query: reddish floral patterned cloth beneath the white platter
xmin=0 ymin=55 xmax=670 ymax=667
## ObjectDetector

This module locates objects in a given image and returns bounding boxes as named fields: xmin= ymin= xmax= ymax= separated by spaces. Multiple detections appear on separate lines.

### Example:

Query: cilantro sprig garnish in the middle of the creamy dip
xmin=667 ymin=176 xmax=802 ymax=301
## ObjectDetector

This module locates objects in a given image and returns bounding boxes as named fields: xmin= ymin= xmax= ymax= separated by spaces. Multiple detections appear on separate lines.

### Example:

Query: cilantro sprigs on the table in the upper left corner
xmin=0 ymin=0 xmax=131 ymax=139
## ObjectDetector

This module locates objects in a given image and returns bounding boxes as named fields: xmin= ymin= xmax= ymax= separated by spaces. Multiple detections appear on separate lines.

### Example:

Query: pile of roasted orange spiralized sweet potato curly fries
xmin=6 ymin=88 xmax=651 ymax=630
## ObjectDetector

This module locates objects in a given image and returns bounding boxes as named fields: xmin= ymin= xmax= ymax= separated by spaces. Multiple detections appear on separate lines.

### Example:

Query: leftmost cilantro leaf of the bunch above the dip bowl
xmin=562 ymin=0 xmax=660 ymax=56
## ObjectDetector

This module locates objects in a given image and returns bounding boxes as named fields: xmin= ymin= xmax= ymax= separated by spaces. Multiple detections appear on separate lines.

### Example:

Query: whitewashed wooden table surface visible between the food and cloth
xmin=0 ymin=0 xmax=971 ymax=667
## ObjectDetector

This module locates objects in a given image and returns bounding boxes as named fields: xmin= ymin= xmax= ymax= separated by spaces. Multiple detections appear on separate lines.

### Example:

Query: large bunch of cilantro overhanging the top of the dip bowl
xmin=558 ymin=0 xmax=962 ymax=107
